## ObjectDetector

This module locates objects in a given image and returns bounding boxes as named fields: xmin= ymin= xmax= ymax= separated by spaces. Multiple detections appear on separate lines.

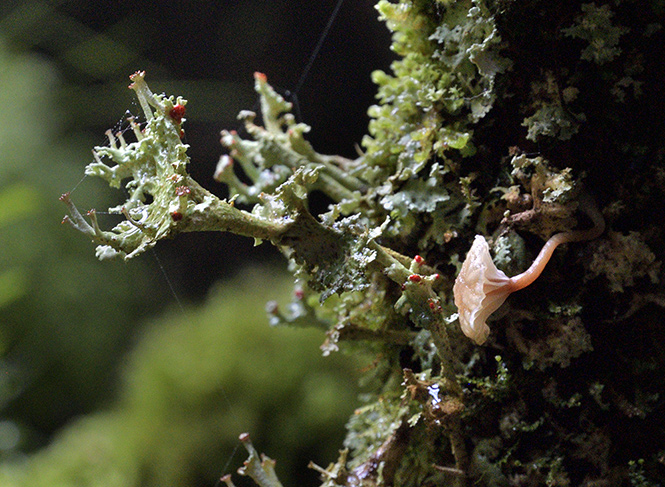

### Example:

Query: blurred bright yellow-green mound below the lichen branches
xmin=0 ymin=269 xmax=357 ymax=487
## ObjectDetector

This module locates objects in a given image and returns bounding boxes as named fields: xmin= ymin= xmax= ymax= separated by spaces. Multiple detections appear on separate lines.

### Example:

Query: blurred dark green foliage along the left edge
xmin=0 ymin=39 xmax=167 ymax=450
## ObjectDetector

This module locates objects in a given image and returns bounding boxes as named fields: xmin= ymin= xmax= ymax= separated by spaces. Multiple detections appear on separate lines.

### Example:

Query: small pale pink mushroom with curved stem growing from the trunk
xmin=453 ymin=199 xmax=605 ymax=345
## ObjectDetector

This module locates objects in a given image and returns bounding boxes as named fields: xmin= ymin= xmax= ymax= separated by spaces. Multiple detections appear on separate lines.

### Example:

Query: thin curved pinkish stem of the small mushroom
xmin=508 ymin=194 xmax=605 ymax=292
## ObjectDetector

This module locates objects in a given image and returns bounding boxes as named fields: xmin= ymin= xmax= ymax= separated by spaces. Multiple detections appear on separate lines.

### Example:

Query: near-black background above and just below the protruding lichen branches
xmin=0 ymin=0 xmax=392 ymax=300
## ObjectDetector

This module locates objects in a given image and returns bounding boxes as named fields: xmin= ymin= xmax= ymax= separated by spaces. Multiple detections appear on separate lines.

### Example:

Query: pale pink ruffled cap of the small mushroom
xmin=453 ymin=235 xmax=512 ymax=345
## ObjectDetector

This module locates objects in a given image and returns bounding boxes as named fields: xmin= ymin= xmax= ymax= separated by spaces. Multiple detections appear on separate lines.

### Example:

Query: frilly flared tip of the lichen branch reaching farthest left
xmin=62 ymin=72 xmax=195 ymax=259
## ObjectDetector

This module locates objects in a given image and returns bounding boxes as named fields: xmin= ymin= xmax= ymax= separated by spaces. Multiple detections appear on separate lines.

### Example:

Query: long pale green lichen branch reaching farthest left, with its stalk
xmin=61 ymin=72 xmax=364 ymax=265
